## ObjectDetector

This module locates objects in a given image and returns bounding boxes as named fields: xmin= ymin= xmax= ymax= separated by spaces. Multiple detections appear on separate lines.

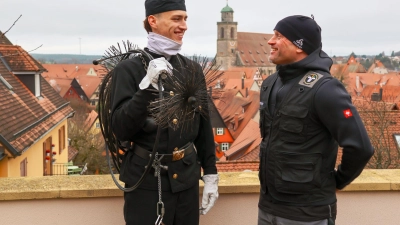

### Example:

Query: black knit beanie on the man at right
xmin=274 ymin=15 xmax=322 ymax=55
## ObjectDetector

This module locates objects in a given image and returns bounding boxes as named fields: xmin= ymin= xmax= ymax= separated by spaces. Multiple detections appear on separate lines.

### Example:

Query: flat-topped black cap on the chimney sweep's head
xmin=144 ymin=0 xmax=186 ymax=17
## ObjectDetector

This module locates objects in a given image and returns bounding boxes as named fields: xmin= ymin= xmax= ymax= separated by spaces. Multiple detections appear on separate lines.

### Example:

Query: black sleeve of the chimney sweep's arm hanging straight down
xmin=194 ymin=65 xmax=217 ymax=175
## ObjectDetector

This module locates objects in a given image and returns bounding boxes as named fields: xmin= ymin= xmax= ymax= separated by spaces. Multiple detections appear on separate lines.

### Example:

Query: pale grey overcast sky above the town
xmin=0 ymin=0 xmax=400 ymax=56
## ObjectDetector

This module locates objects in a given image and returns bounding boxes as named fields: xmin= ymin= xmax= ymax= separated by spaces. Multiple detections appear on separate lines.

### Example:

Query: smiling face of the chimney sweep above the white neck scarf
xmin=148 ymin=10 xmax=187 ymax=44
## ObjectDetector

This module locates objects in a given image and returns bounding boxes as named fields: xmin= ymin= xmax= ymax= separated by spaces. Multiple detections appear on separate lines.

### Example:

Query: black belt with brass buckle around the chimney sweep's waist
xmin=133 ymin=142 xmax=194 ymax=163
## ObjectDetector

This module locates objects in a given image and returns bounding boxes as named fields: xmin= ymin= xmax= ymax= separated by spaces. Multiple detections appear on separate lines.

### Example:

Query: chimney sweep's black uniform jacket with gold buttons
xmin=111 ymin=49 xmax=217 ymax=192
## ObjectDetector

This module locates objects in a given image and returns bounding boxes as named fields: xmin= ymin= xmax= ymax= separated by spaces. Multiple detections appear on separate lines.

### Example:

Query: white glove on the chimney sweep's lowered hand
xmin=200 ymin=174 xmax=219 ymax=215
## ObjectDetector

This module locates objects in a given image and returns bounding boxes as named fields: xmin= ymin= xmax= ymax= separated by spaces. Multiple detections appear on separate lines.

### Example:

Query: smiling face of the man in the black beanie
xmin=268 ymin=30 xmax=307 ymax=65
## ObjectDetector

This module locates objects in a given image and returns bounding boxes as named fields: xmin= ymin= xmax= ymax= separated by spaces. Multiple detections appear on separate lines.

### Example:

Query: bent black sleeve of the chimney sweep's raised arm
xmin=111 ymin=60 xmax=155 ymax=141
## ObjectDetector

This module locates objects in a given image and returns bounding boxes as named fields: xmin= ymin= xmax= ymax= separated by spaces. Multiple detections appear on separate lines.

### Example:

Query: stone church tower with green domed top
xmin=216 ymin=3 xmax=237 ymax=70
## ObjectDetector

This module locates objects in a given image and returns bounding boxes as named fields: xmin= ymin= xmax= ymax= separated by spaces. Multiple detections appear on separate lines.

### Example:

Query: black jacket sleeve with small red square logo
xmin=314 ymin=79 xmax=374 ymax=189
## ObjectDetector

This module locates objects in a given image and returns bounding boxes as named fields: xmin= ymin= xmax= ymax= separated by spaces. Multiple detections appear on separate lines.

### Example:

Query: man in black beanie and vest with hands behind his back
xmin=258 ymin=16 xmax=374 ymax=225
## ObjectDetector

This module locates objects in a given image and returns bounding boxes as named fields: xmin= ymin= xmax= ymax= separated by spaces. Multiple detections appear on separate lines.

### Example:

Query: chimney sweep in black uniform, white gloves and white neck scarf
xmin=111 ymin=0 xmax=219 ymax=225
